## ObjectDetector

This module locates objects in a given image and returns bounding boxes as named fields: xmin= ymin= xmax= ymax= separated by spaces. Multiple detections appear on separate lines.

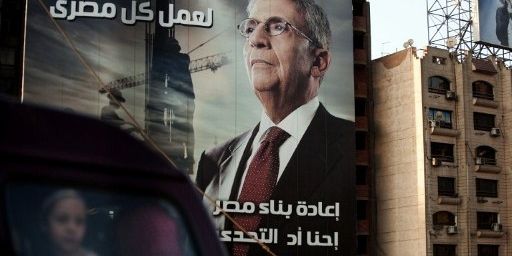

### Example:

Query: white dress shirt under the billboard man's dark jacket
xmin=205 ymin=97 xmax=320 ymax=229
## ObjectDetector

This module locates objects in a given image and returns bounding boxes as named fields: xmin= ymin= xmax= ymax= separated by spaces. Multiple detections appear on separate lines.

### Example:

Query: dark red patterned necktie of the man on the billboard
xmin=233 ymin=126 xmax=290 ymax=256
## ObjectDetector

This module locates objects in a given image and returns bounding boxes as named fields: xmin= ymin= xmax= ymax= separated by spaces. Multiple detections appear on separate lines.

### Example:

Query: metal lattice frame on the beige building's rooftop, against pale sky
xmin=427 ymin=0 xmax=512 ymax=68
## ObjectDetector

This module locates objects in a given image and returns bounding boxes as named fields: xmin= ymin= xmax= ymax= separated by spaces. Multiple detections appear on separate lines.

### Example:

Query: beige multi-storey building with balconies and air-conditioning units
xmin=372 ymin=47 xmax=512 ymax=256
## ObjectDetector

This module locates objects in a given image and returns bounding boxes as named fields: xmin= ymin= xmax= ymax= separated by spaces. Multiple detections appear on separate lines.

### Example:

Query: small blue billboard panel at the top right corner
xmin=472 ymin=0 xmax=512 ymax=48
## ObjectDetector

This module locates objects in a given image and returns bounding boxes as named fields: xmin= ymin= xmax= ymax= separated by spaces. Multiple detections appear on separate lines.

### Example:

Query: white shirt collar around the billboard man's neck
xmin=258 ymin=97 xmax=320 ymax=141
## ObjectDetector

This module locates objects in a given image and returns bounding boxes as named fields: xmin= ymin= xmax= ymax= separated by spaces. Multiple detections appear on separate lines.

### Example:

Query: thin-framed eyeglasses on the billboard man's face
xmin=237 ymin=17 xmax=322 ymax=48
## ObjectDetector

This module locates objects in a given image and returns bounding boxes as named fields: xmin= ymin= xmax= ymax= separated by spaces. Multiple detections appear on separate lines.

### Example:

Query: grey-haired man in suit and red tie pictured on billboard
xmin=196 ymin=0 xmax=355 ymax=255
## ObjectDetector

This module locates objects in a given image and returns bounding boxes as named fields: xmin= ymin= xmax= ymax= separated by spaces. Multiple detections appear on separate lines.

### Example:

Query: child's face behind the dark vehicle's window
xmin=48 ymin=197 xmax=87 ymax=253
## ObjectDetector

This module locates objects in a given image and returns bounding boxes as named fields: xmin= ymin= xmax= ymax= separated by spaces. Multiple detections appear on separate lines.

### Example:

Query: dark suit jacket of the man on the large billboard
xmin=196 ymin=104 xmax=356 ymax=256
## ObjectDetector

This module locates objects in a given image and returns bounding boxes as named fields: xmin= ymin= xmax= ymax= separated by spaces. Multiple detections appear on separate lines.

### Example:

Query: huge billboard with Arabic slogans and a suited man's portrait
xmin=22 ymin=0 xmax=356 ymax=255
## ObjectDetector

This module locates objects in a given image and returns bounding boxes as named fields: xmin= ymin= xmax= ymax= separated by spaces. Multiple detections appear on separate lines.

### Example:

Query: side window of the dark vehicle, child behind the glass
xmin=6 ymin=184 xmax=196 ymax=256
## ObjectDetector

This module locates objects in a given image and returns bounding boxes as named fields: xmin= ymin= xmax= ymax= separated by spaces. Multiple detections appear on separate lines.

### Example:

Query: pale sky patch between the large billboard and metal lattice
xmin=368 ymin=0 xmax=428 ymax=59
